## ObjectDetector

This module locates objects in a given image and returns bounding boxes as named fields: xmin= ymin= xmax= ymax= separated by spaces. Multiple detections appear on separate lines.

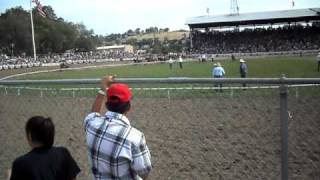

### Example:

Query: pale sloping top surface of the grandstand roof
xmin=186 ymin=8 xmax=320 ymax=25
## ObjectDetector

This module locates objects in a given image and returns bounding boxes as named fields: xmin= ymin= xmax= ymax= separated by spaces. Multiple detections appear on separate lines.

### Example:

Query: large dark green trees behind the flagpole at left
xmin=0 ymin=6 xmax=97 ymax=55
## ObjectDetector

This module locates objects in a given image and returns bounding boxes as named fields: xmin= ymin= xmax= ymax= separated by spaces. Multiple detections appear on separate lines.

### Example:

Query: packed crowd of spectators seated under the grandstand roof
xmin=192 ymin=25 xmax=320 ymax=54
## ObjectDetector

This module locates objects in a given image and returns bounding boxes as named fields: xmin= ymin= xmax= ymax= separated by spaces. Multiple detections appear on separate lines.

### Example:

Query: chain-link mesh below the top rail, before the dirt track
xmin=0 ymin=79 xmax=320 ymax=180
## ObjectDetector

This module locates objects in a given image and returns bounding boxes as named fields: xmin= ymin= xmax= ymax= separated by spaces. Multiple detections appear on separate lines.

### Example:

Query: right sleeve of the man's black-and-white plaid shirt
xmin=131 ymin=134 xmax=152 ymax=176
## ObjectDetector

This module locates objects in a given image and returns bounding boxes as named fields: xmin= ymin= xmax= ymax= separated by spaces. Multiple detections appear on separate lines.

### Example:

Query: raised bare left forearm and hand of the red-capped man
xmin=91 ymin=75 xmax=116 ymax=113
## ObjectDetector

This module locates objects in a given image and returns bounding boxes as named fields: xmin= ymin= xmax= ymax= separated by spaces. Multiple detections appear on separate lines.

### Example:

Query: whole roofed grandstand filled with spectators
xmin=186 ymin=8 xmax=320 ymax=54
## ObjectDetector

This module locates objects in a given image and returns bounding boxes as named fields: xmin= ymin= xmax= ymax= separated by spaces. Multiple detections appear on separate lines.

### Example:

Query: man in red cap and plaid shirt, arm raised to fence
xmin=84 ymin=76 xmax=152 ymax=180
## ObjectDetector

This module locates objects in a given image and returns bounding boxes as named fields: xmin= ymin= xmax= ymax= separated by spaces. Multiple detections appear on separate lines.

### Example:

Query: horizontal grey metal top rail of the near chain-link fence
xmin=0 ymin=77 xmax=320 ymax=85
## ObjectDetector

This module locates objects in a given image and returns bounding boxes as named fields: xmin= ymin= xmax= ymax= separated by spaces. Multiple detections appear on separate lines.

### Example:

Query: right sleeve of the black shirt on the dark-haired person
xmin=63 ymin=148 xmax=81 ymax=179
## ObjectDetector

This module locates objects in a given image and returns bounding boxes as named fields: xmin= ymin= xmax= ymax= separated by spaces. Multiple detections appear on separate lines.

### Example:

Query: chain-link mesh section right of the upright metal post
xmin=288 ymin=86 xmax=320 ymax=179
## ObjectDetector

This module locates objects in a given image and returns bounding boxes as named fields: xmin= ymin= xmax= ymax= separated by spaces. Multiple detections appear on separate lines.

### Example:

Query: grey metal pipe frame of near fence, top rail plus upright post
xmin=0 ymin=76 xmax=320 ymax=180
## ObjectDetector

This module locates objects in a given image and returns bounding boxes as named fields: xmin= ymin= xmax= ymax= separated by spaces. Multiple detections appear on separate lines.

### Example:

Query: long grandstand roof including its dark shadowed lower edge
xmin=186 ymin=8 xmax=320 ymax=28
